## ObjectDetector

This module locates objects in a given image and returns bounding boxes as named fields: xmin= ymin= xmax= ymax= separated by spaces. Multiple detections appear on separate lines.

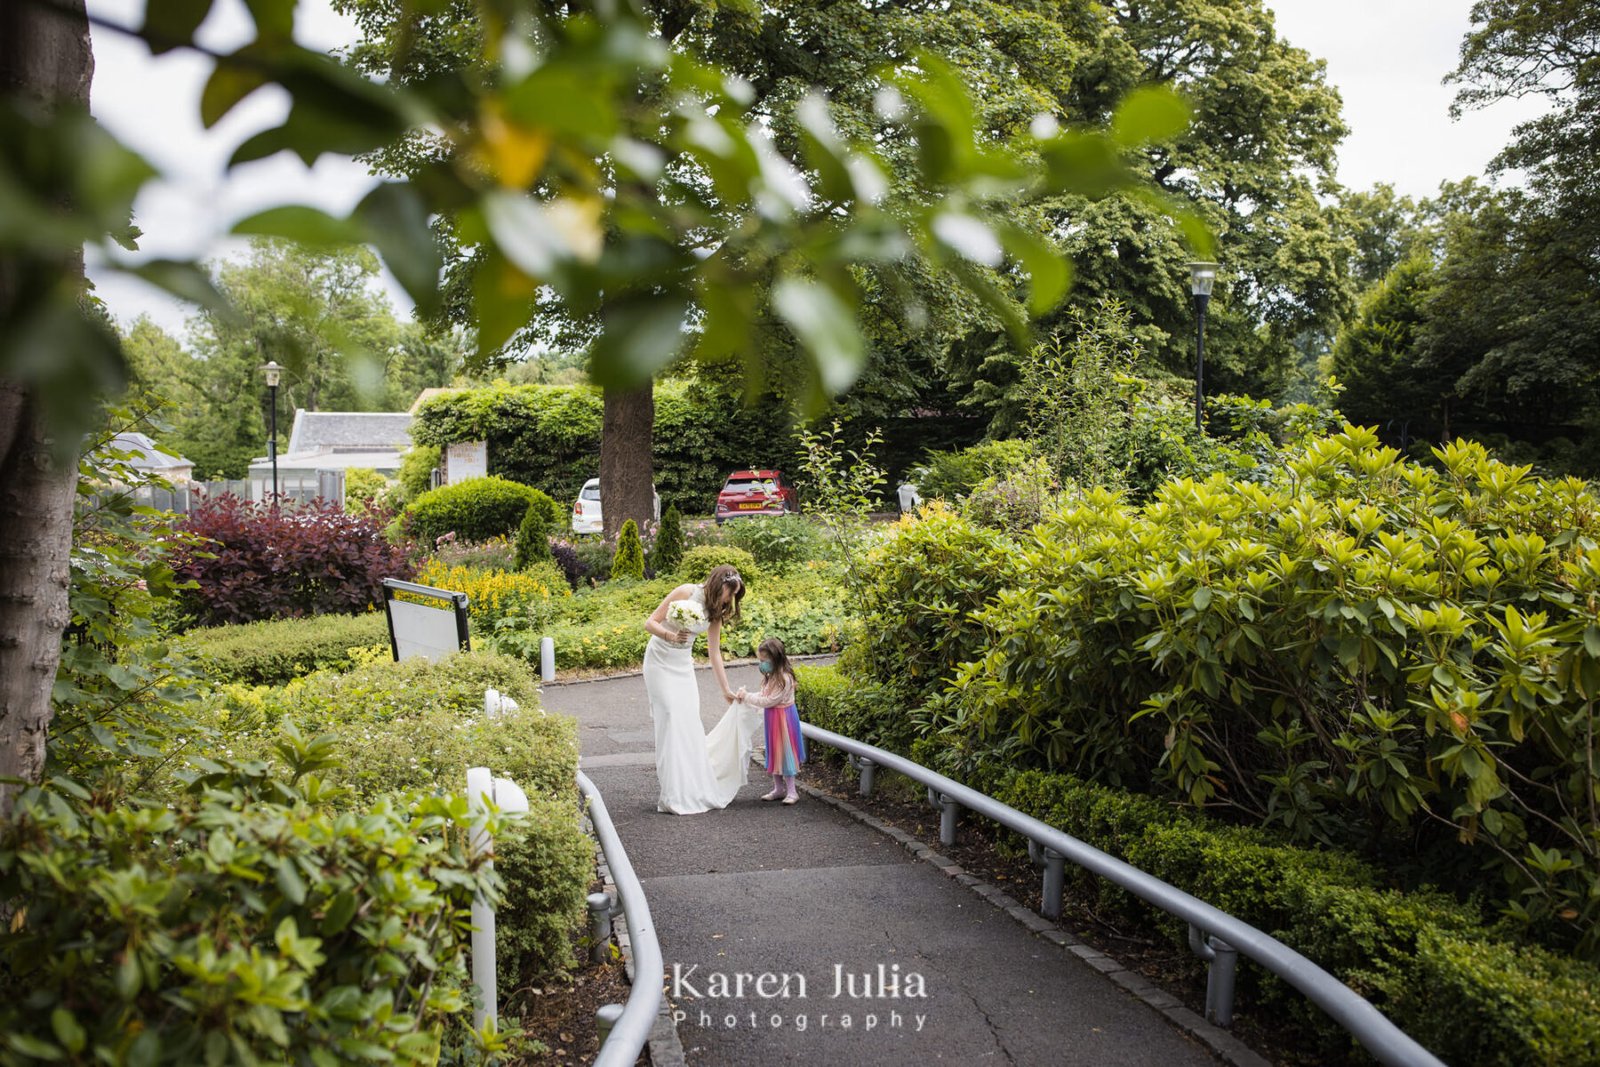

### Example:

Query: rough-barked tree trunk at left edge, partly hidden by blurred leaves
xmin=0 ymin=0 xmax=94 ymax=819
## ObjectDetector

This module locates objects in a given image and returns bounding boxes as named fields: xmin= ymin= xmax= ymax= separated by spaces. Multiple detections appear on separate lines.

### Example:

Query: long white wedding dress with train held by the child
xmin=645 ymin=585 xmax=762 ymax=816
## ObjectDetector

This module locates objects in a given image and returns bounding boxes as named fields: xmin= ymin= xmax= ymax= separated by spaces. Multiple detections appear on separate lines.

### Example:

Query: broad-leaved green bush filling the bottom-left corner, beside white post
xmin=0 ymin=755 xmax=499 ymax=1064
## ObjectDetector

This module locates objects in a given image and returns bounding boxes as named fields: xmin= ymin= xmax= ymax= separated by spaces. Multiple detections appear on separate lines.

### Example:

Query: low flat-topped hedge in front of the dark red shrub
xmin=179 ymin=611 xmax=389 ymax=685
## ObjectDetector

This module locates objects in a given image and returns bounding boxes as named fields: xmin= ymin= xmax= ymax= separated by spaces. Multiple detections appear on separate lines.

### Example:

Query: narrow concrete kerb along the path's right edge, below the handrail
xmin=795 ymin=781 xmax=1272 ymax=1067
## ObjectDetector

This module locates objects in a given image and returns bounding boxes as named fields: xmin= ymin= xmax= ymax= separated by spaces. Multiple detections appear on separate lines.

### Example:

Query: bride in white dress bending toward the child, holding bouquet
xmin=645 ymin=565 xmax=760 ymax=816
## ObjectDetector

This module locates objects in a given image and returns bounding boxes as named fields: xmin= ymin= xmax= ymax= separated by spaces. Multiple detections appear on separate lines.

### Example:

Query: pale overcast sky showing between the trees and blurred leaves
xmin=90 ymin=0 xmax=1539 ymax=333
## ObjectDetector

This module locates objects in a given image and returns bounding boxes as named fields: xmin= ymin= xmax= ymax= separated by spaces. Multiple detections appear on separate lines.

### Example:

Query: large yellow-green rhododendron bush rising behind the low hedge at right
xmin=864 ymin=430 xmax=1600 ymax=952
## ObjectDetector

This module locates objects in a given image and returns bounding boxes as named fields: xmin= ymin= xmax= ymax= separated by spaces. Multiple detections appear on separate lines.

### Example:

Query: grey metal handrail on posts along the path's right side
xmin=800 ymin=721 xmax=1445 ymax=1067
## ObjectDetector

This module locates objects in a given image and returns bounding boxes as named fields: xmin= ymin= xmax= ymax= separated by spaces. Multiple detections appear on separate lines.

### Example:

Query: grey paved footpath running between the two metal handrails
xmin=544 ymin=667 xmax=1216 ymax=1067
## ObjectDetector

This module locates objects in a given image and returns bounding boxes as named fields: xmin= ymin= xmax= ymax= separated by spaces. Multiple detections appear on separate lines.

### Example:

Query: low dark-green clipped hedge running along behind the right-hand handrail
xmin=797 ymin=667 xmax=1600 ymax=1067
